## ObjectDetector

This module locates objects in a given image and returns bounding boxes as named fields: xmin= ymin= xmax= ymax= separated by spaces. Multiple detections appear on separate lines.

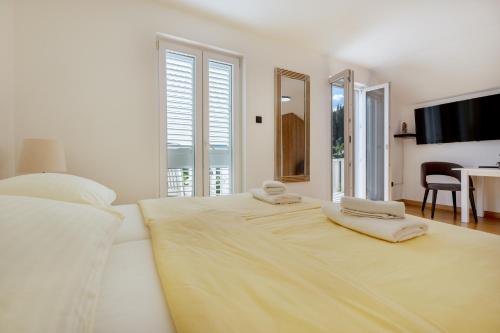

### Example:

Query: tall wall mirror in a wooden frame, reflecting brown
xmin=274 ymin=68 xmax=310 ymax=182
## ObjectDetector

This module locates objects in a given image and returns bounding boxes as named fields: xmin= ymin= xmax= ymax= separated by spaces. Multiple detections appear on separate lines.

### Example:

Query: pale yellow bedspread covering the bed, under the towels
xmin=140 ymin=195 xmax=500 ymax=333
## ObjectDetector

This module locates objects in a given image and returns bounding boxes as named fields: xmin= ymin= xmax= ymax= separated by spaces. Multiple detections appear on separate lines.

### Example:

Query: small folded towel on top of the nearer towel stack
xmin=340 ymin=197 xmax=405 ymax=219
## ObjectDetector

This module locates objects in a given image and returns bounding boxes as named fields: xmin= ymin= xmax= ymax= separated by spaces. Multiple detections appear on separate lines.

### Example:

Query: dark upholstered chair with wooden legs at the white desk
xmin=420 ymin=162 xmax=477 ymax=223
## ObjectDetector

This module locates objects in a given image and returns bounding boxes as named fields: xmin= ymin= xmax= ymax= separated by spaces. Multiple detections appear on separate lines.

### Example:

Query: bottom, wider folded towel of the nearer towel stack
xmin=321 ymin=203 xmax=428 ymax=243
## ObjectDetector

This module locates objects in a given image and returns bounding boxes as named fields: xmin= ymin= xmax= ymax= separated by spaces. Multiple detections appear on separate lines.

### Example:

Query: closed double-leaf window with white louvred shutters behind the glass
xmin=159 ymin=41 xmax=240 ymax=196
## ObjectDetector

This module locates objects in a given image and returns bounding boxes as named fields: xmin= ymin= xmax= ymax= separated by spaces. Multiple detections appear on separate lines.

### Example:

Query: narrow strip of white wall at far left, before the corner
xmin=0 ymin=0 xmax=14 ymax=179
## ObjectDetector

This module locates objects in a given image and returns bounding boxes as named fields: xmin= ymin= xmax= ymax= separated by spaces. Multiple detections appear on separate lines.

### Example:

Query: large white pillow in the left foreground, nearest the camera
xmin=0 ymin=195 xmax=120 ymax=333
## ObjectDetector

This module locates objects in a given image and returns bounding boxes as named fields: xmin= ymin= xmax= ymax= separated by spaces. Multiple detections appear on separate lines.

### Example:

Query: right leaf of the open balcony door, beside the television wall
xmin=354 ymin=83 xmax=391 ymax=201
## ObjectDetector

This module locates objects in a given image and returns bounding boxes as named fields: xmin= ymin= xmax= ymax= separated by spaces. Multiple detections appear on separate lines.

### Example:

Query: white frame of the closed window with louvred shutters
xmin=157 ymin=36 xmax=243 ymax=197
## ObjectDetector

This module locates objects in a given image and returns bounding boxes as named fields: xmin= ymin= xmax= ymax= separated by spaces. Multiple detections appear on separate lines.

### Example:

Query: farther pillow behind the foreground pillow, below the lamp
xmin=0 ymin=173 xmax=116 ymax=207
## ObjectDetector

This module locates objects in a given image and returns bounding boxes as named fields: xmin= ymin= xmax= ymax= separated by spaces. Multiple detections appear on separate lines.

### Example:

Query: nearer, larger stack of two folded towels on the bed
xmin=322 ymin=197 xmax=428 ymax=243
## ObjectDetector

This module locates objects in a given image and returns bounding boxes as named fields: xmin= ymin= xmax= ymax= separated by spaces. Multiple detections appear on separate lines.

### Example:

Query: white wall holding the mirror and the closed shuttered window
xmin=15 ymin=0 xmax=348 ymax=203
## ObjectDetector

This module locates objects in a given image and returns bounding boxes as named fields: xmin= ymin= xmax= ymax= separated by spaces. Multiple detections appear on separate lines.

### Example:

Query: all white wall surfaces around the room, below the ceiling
xmin=11 ymin=0 xmax=500 ymax=211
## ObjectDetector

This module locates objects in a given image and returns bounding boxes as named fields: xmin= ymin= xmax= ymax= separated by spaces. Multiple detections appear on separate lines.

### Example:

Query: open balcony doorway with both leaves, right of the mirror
xmin=329 ymin=70 xmax=390 ymax=202
